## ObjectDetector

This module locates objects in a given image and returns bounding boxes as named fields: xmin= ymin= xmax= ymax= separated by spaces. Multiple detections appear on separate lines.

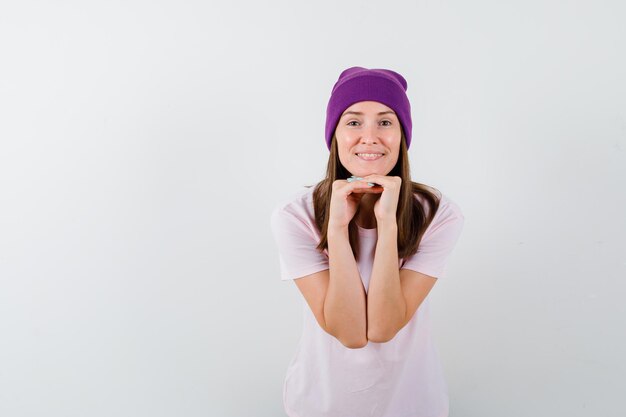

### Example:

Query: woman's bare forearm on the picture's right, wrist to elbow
xmin=367 ymin=219 xmax=406 ymax=342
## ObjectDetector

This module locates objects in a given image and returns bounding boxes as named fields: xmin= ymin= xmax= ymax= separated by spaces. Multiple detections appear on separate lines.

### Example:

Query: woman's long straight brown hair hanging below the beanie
xmin=307 ymin=132 xmax=440 ymax=260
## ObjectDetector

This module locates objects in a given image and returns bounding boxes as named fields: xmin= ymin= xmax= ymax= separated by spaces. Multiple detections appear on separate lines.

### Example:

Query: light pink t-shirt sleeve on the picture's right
xmin=400 ymin=202 xmax=465 ymax=278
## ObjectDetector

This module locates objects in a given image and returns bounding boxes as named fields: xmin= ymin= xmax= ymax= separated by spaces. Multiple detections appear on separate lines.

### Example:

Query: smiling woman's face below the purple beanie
xmin=335 ymin=101 xmax=402 ymax=177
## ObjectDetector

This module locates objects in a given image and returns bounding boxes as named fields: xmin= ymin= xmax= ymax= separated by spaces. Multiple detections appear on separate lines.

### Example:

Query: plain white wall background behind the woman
xmin=0 ymin=0 xmax=626 ymax=417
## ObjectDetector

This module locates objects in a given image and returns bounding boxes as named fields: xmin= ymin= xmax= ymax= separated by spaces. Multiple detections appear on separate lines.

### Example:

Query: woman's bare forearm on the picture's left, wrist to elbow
xmin=324 ymin=227 xmax=367 ymax=348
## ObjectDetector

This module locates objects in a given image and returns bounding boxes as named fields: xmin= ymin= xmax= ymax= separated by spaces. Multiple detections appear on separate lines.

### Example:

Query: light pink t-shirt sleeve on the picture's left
xmin=271 ymin=206 xmax=329 ymax=281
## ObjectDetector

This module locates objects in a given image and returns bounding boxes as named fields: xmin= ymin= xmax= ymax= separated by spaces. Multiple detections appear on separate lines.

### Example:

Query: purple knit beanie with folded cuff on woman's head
xmin=326 ymin=67 xmax=412 ymax=150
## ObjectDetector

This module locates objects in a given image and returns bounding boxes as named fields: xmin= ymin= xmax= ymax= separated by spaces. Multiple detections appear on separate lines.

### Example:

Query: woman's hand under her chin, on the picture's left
xmin=328 ymin=180 xmax=383 ymax=229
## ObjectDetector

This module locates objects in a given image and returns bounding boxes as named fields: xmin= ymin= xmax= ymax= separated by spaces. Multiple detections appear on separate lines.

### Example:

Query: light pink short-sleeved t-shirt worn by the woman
xmin=271 ymin=187 xmax=464 ymax=417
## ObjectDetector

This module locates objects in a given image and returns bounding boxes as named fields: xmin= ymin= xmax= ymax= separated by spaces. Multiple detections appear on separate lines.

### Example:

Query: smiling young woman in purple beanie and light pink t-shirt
xmin=271 ymin=67 xmax=464 ymax=417
